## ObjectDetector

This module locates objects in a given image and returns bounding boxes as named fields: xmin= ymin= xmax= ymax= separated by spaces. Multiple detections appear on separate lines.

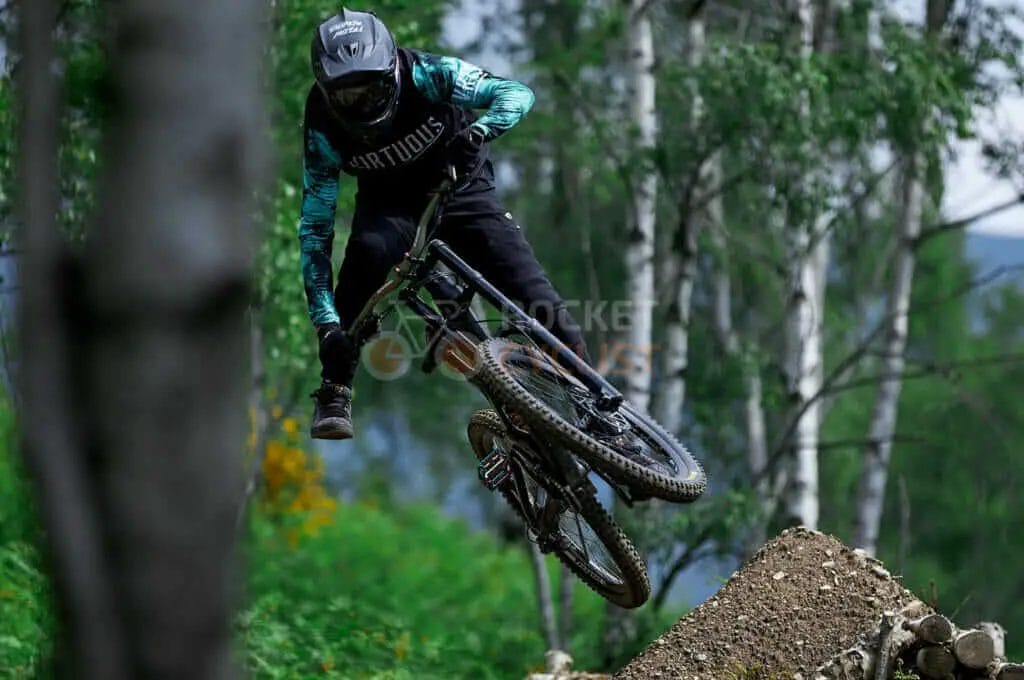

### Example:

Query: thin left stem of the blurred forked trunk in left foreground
xmin=18 ymin=0 xmax=128 ymax=680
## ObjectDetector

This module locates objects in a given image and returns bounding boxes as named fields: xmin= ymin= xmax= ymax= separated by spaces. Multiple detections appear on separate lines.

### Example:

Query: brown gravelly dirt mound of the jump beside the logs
xmin=614 ymin=528 xmax=916 ymax=680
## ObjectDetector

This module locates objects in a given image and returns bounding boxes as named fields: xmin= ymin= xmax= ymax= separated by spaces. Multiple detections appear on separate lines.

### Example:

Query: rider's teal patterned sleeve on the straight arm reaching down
xmin=299 ymin=99 xmax=341 ymax=326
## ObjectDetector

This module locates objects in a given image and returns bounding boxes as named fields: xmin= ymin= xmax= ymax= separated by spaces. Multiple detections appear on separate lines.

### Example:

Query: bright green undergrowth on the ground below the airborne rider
xmin=238 ymin=504 xmax=603 ymax=679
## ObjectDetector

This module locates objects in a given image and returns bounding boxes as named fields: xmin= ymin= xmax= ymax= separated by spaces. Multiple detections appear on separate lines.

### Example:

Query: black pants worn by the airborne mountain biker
xmin=321 ymin=177 xmax=587 ymax=385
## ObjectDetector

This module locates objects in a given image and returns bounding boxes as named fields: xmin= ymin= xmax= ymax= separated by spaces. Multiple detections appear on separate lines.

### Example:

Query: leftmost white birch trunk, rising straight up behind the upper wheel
xmin=625 ymin=0 xmax=657 ymax=412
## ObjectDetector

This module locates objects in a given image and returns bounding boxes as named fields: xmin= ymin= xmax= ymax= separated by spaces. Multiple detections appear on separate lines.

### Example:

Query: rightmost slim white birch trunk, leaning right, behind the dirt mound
xmin=853 ymin=0 xmax=953 ymax=554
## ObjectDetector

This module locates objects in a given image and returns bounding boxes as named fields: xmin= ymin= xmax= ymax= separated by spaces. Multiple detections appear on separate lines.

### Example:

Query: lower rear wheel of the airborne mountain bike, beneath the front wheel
xmin=467 ymin=411 xmax=650 ymax=608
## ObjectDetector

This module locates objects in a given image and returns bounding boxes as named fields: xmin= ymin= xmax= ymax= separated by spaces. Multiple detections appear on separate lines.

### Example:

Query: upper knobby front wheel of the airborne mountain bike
xmin=472 ymin=339 xmax=707 ymax=503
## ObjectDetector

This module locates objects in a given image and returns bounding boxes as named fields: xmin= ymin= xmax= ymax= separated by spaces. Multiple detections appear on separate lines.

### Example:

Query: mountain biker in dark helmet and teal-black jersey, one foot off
xmin=299 ymin=9 xmax=586 ymax=439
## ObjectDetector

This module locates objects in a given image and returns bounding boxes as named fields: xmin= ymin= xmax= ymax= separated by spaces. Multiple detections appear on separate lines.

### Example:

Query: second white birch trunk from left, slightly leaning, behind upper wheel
xmin=656 ymin=3 xmax=704 ymax=434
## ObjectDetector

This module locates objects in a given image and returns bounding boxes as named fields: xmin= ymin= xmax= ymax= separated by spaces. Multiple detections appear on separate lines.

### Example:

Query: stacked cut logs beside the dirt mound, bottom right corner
xmin=797 ymin=602 xmax=1024 ymax=680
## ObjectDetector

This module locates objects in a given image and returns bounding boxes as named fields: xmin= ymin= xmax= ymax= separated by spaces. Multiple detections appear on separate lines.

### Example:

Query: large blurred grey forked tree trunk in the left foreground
xmin=20 ymin=0 xmax=262 ymax=680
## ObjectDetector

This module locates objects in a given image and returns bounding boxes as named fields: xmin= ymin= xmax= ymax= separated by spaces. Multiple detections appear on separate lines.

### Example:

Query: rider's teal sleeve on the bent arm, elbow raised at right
xmin=413 ymin=52 xmax=534 ymax=141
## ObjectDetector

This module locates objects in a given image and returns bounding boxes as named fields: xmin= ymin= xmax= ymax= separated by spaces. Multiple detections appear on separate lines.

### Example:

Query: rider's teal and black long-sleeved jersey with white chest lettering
xmin=299 ymin=49 xmax=534 ymax=325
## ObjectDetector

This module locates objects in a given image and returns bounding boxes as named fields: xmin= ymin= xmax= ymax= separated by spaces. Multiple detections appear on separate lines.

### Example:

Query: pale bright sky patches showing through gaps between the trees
xmin=444 ymin=0 xmax=1024 ymax=239
